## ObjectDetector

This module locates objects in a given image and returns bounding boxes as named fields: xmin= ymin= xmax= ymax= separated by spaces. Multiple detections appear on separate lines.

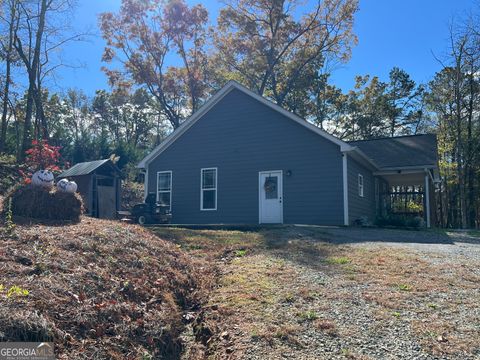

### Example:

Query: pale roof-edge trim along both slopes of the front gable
xmin=137 ymin=80 xmax=352 ymax=168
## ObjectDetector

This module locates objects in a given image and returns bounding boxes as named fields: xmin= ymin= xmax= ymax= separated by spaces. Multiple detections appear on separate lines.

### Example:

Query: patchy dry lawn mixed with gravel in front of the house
xmin=151 ymin=226 xmax=480 ymax=359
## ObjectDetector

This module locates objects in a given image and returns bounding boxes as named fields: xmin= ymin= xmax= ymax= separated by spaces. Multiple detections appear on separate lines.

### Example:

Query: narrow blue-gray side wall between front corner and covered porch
xmin=347 ymin=157 xmax=376 ymax=224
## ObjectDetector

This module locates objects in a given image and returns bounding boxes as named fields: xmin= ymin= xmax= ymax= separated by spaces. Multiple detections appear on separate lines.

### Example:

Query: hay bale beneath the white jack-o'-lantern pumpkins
xmin=4 ymin=185 xmax=83 ymax=221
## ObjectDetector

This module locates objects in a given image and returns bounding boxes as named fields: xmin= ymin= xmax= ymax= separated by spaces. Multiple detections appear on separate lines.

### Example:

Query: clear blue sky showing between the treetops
xmin=57 ymin=0 xmax=479 ymax=95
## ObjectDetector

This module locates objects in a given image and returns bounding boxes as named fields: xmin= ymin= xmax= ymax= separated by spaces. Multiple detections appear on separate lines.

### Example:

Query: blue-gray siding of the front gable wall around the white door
xmin=148 ymin=90 xmax=343 ymax=225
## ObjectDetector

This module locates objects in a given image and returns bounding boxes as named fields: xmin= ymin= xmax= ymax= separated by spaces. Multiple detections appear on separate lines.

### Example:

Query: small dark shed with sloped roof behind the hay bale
xmin=57 ymin=159 xmax=122 ymax=219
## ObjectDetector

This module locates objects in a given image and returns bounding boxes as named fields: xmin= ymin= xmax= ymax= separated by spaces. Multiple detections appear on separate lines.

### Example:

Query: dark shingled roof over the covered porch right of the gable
xmin=348 ymin=134 xmax=438 ymax=170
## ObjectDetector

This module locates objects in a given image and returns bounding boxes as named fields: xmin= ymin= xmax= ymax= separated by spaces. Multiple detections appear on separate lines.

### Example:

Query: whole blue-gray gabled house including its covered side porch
xmin=138 ymin=81 xmax=438 ymax=226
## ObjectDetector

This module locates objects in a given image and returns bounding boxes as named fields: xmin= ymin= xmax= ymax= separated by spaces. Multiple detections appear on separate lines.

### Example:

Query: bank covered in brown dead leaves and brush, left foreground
xmin=0 ymin=218 xmax=211 ymax=359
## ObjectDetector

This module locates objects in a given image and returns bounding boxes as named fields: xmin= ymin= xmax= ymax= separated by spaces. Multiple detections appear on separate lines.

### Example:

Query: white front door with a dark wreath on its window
xmin=258 ymin=170 xmax=283 ymax=224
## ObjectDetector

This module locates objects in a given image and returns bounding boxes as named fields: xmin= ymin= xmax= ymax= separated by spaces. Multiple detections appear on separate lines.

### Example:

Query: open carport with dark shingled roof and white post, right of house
xmin=350 ymin=134 xmax=440 ymax=227
